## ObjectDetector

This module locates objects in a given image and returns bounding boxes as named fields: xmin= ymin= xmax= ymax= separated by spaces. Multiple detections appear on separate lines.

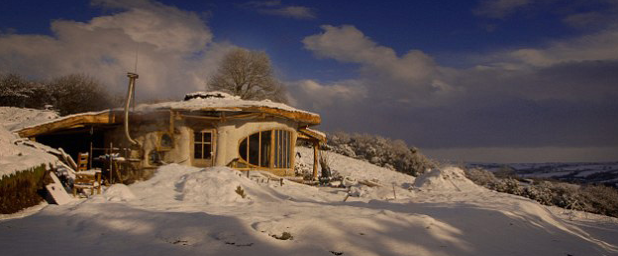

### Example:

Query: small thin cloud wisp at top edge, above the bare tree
xmin=241 ymin=1 xmax=316 ymax=19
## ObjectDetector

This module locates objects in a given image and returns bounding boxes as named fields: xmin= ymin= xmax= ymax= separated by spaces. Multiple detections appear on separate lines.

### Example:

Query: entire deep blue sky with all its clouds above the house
xmin=0 ymin=0 xmax=618 ymax=162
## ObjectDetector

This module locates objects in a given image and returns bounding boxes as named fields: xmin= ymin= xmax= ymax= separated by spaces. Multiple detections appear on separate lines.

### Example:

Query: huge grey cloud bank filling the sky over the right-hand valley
xmin=295 ymin=25 xmax=618 ymax=151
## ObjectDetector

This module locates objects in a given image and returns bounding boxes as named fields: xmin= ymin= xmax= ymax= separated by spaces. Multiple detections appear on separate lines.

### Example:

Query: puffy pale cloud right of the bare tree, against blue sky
xmin=303 ymin=25 xmax=445 ymax=100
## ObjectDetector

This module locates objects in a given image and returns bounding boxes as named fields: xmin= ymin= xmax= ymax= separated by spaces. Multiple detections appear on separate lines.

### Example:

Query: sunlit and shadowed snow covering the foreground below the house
xmin=0 ymin=150 xmax=618 ymax=255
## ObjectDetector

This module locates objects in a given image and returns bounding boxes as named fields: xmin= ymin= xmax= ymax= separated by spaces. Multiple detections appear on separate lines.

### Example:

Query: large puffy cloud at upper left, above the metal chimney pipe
xmin=0 ymin=0 xmax=231 ymax=98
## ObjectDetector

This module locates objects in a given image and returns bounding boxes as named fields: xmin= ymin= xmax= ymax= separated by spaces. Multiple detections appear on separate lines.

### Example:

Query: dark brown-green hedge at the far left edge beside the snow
xmin=0 ymin=165 xmax=48 ymax=214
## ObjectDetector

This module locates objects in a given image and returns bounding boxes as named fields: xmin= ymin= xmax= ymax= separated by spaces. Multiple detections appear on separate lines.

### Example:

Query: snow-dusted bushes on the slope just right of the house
xmin=327 ymin=132 xmax=436 ymax=176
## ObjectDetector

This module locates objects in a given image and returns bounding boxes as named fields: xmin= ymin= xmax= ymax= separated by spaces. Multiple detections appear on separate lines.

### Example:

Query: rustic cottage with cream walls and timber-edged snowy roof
xmin=18 ymin=92 xmax=326 ymax=178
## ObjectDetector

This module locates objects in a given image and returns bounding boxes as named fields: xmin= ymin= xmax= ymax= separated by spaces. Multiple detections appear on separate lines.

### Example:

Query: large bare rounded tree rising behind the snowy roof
xmin=207 ymin=48 xmax=287 ymax=103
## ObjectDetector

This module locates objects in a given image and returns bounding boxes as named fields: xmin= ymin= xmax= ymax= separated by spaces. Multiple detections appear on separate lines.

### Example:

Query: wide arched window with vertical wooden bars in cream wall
xmin=238 ymin=130 xmax=292 ymax=168
